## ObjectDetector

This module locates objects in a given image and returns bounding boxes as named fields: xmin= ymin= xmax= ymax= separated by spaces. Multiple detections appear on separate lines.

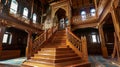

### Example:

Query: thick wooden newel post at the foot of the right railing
xmin=81 ymin=36 xmax=88 ymax=61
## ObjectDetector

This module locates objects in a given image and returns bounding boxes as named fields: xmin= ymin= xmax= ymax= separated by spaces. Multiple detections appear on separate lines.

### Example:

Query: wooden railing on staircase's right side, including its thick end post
xmin=66 ymin=29 xmax=88 ymax=61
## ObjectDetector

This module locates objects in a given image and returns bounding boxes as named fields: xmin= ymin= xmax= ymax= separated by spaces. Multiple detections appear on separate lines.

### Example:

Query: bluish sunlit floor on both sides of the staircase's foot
xmin=0 ymin=56 xmax=120 ymax=67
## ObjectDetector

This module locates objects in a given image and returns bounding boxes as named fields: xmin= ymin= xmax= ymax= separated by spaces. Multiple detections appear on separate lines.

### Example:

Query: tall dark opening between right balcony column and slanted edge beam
xmin=103 ymin=13 xmax=115 ymax=56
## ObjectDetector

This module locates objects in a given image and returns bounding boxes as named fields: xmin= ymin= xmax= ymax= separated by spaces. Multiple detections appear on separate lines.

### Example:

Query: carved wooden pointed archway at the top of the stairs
xmin=50 ymin=0 xmax=71 ymax=25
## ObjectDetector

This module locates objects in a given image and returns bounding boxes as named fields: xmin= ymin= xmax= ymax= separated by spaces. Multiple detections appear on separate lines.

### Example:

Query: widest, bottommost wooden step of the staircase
xmin=23 ymin=60 xmax=91 ymax=67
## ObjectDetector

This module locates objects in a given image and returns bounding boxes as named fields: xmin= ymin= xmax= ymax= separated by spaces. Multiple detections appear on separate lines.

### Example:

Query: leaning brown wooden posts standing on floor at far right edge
xmin=112 ymin=33 xmax=120 ymax=62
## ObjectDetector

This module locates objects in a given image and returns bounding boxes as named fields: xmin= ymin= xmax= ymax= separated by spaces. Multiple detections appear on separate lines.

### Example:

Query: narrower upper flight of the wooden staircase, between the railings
xmin=42 ymin=30 xmax=67 ymax=48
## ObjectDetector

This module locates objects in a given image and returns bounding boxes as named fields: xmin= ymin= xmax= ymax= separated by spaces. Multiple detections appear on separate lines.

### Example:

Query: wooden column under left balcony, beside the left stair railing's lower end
xmin=26 ymin=31 xmax=32 ymax=59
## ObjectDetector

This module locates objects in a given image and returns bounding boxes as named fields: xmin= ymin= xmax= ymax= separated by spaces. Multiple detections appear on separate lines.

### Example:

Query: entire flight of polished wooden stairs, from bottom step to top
xmin=22 ymin=30 xmax=90 ymax=67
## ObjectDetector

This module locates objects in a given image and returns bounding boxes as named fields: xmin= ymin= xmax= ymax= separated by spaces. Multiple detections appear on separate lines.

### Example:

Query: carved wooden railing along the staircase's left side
xmin=32 ymin=26 xmax=58 ymax=55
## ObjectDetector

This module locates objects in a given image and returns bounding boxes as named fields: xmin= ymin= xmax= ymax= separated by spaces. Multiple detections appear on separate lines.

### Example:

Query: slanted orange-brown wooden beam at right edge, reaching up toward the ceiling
xmin=111 ymin=6 xmax=120 ymax=42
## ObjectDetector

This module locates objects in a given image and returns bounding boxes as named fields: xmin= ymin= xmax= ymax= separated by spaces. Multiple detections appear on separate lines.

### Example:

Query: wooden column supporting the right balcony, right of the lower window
xmin=99 ymin=26 xmax=108 ymax=57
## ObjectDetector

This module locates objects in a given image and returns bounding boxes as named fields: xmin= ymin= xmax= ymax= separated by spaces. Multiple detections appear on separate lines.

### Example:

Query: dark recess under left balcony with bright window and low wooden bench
xmin=0 ymin=27 xmax=28 ymax=60
